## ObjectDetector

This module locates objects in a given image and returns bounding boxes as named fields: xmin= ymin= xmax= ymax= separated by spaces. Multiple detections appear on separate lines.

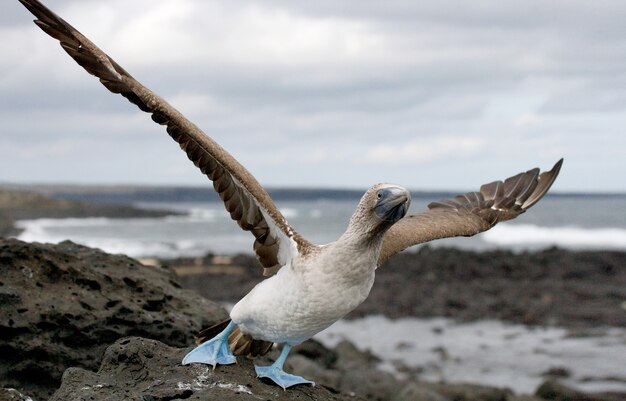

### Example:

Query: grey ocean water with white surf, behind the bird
xmin=12 ymin=195 xmax=626 ymax=257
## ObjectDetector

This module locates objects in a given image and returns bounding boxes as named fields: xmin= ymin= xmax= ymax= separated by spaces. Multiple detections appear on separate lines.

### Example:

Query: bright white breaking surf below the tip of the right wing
xmin=482 ymin=224 xmax=626 ymax=249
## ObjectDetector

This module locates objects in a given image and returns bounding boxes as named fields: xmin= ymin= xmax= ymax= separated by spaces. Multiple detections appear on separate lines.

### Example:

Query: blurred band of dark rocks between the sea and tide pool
xmin=172 ymin=247 xmax=626 ymax=328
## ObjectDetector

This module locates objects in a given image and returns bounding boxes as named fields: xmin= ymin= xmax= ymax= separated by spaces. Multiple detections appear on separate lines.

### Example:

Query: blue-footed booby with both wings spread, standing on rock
xmin=19 ymin=0 xmax=562 ymax=388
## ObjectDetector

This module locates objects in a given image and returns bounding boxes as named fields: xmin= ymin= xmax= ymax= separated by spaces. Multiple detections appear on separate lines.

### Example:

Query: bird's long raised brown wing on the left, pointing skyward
xmin=20 ymin=0 xmax=312 ymax=275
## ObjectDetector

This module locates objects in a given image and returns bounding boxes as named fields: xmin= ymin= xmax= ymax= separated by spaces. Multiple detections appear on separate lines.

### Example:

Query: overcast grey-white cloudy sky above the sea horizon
xmin=0 ymin=0 xmax=626 ymax=192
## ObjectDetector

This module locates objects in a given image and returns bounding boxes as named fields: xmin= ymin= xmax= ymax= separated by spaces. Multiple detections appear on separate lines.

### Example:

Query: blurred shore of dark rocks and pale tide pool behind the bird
xmin=166 ymin=247 xmax=626 ymax=394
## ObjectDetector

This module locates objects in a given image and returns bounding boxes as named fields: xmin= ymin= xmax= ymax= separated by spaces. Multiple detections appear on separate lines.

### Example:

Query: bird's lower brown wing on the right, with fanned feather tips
xmin=378 ymin=159 xmax=563 ymax=266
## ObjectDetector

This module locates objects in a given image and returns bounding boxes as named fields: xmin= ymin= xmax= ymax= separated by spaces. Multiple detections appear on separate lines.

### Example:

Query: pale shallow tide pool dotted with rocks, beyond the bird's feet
xmin=314 ymin=315 xmax=626 ymax=394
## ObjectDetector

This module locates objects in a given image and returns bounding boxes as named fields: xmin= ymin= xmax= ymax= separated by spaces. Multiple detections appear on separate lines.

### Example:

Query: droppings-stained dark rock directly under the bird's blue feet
xmin=51 ymin=337 xmax=360 ymax=401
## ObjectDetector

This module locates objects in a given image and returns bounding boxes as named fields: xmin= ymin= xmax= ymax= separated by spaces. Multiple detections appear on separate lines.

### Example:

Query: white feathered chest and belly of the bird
xmin=231 ymin=245 xmax=376 ymax=344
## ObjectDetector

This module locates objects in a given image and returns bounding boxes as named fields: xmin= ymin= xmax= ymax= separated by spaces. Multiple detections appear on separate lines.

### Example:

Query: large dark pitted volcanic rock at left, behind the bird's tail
xmin=0 ymin=238 xmax=227 ymax=399
